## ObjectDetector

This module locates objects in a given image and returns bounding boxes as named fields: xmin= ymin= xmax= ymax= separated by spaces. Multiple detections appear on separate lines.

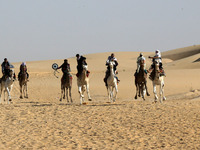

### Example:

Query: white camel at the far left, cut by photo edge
xmin=0 ymin=69 xmax=14 ymax=104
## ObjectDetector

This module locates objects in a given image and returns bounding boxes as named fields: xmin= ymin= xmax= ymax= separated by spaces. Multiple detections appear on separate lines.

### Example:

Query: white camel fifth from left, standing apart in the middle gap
xmin=107 ymin=61 xmax=118 ymax=102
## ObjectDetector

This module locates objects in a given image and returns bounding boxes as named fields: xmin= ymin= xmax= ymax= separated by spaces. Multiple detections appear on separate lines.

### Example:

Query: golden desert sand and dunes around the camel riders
xmin=0 ymin=45 xmax=200 ymax=150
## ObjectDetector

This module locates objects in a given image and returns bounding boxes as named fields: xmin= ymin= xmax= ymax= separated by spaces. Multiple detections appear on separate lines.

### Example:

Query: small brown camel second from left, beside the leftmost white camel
xmin=19 ymin=66 xmax=28 ymax=99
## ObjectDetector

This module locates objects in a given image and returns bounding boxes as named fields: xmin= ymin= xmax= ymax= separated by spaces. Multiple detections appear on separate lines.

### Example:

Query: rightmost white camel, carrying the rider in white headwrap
xmin=152 ymin=61 xmax=166 ymax=103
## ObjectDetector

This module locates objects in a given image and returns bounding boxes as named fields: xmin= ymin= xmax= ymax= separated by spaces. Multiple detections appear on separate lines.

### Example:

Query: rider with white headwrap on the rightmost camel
xmin=148 ymin=50 xmax=165 ymax=79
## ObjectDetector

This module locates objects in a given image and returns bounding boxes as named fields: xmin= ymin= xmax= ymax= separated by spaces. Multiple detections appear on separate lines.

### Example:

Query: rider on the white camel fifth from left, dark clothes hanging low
xmin=104 ymin=53 xmax=120 ymax=86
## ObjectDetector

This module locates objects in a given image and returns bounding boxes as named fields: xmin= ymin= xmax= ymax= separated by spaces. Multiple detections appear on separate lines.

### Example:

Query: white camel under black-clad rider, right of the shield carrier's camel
xmin=77 ymin=65 xmax=92 ymax=104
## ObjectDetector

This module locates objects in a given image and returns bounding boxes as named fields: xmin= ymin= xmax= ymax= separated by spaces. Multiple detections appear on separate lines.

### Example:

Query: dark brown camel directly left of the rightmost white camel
xmin=135 ymin=60 xmax=150 ymax=100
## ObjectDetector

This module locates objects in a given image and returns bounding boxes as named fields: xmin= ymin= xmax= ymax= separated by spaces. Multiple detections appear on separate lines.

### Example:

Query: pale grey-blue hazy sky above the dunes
xmin=0 ymin=0 xmax=200 ymax=62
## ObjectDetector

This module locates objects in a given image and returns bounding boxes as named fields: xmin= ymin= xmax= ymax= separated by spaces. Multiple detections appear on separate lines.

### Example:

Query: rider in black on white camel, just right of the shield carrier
xmin=76 ymin=54 xmax=90 ymax=77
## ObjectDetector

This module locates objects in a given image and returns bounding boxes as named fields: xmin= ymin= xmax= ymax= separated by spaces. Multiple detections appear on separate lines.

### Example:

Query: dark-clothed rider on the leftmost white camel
xmin=1 ymin=58 xmax=16 ymax=80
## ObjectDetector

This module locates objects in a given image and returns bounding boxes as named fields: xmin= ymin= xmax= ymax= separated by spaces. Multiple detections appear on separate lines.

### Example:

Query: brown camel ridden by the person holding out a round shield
xmin=60 ymin=72 xmax=73 ymax=103
